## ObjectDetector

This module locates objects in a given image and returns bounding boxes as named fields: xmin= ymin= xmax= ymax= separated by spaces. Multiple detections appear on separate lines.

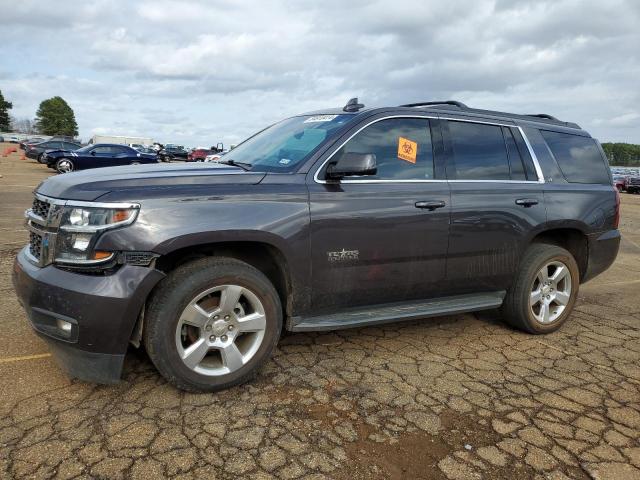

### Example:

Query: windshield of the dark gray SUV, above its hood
xmin=221 ymin=115 xmax=354 ymax=172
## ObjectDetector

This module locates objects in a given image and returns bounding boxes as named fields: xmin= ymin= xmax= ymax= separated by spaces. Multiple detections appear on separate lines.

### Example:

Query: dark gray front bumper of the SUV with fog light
xmin=13 ymin=247 xmax=164 ymax=383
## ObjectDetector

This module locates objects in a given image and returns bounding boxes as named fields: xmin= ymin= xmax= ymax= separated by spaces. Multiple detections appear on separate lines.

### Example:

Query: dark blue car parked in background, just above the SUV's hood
xmin=44 ymin=143 xmax=158 ymax=173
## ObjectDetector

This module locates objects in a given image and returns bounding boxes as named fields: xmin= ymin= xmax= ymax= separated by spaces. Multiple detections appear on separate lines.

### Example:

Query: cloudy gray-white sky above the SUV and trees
xmin=0 ymin=0 xmax=640 ymax=146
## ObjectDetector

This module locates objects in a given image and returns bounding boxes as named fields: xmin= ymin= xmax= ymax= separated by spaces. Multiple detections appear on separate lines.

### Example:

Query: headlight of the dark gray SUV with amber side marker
xmin=56 ymin=205 xmax=140 ymax=264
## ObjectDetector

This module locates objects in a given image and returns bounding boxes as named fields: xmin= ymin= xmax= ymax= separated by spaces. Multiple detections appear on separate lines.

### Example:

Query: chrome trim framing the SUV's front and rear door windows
xmin=313 ymin=115 xmax=545 ymax=185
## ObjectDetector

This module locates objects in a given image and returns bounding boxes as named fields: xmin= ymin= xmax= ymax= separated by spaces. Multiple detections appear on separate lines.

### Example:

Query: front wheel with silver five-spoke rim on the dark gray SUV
xmin=143 ymin=257 xmax=282 ymax=392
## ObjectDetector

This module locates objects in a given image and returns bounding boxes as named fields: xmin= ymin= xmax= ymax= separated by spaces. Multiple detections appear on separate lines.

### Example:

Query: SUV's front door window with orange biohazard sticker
xmin=333 ymin=118 xmax=433 ymax=180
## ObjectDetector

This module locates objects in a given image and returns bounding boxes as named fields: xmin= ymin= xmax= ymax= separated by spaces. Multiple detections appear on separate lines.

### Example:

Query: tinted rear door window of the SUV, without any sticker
xmin=449 ymin=121 xmax=510 ymax=180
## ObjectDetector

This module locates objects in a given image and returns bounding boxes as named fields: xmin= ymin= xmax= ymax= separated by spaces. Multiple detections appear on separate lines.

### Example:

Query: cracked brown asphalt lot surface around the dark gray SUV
xmin=0 ymin=144 xmax=640 ymax=480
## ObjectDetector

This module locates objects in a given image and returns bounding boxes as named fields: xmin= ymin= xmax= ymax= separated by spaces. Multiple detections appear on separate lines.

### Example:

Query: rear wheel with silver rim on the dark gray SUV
xmin=502 ymin=243 xmax=580 ymax=334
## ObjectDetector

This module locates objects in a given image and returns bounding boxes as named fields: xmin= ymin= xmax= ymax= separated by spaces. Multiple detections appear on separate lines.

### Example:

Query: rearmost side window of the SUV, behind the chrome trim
xmin=540 ymin=130 xmax=609 ymax=184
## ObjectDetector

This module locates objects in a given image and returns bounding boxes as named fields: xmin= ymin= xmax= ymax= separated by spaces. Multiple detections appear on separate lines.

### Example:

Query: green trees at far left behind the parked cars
xmin=0 ymin=91 xmax=78 ymax=137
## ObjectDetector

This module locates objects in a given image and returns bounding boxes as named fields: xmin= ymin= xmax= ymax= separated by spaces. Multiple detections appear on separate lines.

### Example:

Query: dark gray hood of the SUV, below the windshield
xmin=36 ymin=163 xmax=265 ymax=202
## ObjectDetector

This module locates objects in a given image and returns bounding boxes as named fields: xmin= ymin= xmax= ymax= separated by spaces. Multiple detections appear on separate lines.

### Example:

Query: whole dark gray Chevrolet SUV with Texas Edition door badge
xmin=13 ymin=99 xmax=620 ymax=391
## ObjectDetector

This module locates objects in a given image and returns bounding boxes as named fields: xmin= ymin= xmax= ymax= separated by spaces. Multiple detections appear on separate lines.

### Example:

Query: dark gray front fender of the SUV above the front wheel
xmin=96 ymin=184 xmax=311 ymax=312
